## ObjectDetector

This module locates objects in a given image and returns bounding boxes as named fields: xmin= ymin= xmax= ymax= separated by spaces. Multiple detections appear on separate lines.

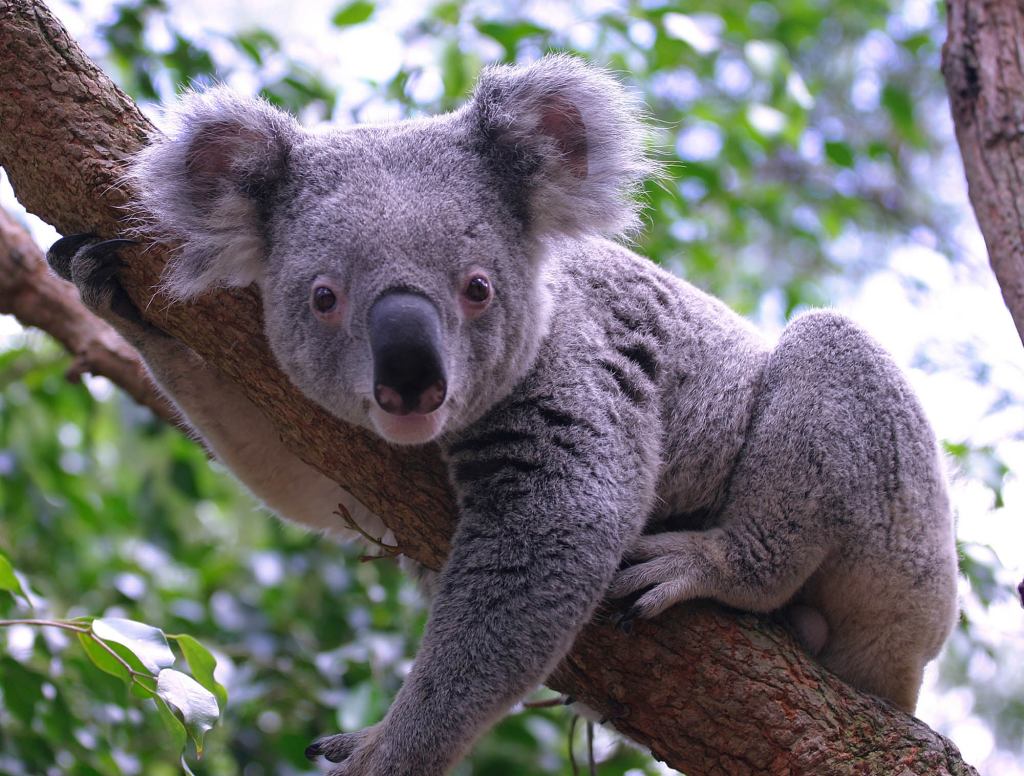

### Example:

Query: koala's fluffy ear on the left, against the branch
xmin=128 ymin=88 xmax=301 ymax=298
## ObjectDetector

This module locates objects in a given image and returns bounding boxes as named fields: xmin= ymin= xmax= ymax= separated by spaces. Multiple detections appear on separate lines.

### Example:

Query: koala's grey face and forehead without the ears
xmin=259 ymin=121 xmax=547 ymax=443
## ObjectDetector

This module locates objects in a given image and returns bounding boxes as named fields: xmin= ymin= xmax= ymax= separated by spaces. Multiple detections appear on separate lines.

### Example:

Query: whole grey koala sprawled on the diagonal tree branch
xmin=49 ymin=55 xmax=956 ymax=776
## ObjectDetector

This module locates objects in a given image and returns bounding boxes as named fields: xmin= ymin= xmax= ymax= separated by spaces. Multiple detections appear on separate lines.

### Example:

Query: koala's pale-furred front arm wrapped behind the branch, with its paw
xmin=47 ymin=234 xmax=384 ymax=536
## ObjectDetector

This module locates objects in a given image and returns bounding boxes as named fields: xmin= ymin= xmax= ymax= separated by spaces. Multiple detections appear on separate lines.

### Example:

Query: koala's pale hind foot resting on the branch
xmin=608 ymin=531 xmax=707 ymax=618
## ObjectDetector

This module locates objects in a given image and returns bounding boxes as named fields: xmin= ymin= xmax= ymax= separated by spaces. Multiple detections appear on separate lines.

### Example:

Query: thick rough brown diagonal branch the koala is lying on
xmin=0 ymin=0 xmax=976 ymax=776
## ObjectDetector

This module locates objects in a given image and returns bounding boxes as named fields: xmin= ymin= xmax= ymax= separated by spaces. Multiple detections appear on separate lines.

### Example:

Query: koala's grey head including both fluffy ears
xmin=132 ymin=56 xmax=650 ymax=443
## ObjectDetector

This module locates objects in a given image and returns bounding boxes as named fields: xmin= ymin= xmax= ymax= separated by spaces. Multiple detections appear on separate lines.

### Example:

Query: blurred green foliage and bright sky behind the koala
xmin=0 ymin=0 xmax=1024 ymax=776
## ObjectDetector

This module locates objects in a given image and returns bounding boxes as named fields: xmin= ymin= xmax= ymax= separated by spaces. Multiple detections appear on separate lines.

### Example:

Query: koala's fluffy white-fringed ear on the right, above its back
xmin=469 ymin=55 xmax=656 ymax=235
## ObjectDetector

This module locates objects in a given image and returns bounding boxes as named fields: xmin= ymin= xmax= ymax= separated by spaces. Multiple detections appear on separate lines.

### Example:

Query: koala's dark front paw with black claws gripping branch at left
xmin=46 ymin=234 xmax=148 ymax=329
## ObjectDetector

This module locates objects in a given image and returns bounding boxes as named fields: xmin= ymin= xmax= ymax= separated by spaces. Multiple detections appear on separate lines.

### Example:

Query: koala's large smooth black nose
xmin=369 ymin=291 xmax=447 ymax=415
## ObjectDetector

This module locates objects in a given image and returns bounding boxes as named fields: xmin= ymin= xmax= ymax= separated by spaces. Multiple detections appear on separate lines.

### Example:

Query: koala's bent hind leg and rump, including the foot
xmin=611 ymin=312 xmax=955 ymax=710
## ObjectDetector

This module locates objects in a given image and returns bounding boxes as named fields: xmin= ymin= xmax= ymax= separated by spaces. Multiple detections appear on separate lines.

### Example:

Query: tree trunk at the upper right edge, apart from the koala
xmin=942 ymin=0 xmax=1024 ymax=340
